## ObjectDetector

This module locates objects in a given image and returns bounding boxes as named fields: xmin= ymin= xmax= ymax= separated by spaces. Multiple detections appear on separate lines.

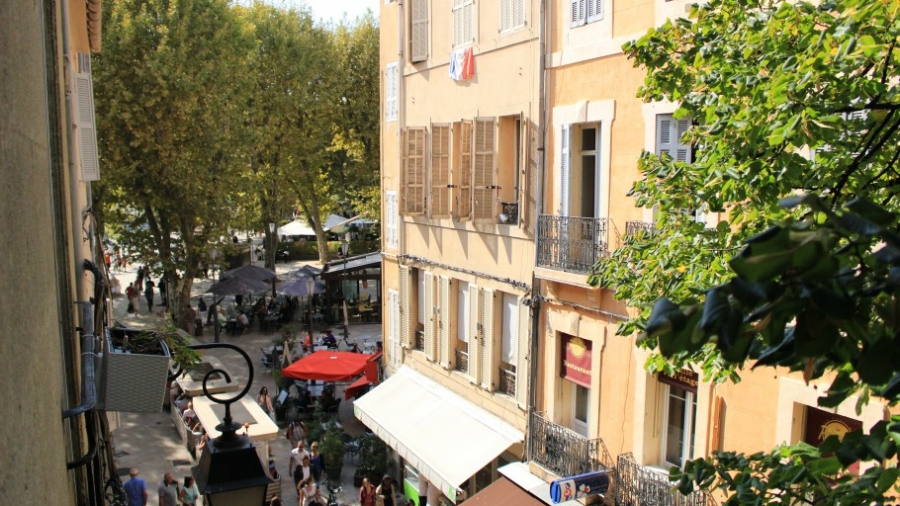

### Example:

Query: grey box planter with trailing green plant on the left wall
xmin=100 ymin=325 xmax=200 ymax=413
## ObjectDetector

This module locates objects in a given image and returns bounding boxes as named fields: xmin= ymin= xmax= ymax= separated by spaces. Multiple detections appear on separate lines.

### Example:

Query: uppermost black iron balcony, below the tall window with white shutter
xmin=537 ymin=214 xmax=607 ymax=273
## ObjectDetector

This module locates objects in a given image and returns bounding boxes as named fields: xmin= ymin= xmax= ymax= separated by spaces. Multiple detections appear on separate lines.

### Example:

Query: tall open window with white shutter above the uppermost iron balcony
xmin=560 ymin=124 xmax=603 ymax=218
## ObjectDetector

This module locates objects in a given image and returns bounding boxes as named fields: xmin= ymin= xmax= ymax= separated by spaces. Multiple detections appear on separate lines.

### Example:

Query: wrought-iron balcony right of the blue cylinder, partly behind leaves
xmin=613 ymin=453 xmax=711 ymax=506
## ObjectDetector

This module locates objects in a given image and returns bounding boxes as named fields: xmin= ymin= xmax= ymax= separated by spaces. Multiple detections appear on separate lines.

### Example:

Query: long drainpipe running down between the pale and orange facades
xmin=525 ymin=0 xmax=551 ymax=458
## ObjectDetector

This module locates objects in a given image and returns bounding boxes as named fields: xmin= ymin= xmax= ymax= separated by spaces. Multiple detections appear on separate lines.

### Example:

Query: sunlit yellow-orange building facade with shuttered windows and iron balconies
xmin=375 ymin=0 xmax=887 ymax=504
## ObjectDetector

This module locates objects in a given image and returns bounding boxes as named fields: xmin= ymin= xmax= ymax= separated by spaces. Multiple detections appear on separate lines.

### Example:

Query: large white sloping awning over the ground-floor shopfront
xmin=354 ymin=366 xmax=525 ymax=500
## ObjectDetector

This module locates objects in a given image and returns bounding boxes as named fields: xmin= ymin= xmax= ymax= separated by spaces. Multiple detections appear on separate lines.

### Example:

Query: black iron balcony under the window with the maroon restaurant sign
xmin=528 ymin=413 xmax=612 ymax=477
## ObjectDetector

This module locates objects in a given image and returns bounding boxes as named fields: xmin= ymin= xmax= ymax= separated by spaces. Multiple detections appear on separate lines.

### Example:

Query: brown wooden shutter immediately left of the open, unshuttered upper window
xmin=472 ymin=118 xmax=497 ymax=222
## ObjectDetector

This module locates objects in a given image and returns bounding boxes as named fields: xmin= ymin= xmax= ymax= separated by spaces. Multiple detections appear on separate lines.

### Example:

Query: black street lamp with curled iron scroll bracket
xmin=171 ymin=343 xmax=275 ymax=506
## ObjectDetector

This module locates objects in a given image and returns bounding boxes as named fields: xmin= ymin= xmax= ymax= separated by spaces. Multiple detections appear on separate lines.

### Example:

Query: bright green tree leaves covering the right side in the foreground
xmin=590 ymin=0 xmax=900 ymax=504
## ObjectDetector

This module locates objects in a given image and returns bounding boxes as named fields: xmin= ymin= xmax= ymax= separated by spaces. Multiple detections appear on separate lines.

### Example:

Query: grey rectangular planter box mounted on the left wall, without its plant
xmin=100 ymin=328 xmax=171 ymax=413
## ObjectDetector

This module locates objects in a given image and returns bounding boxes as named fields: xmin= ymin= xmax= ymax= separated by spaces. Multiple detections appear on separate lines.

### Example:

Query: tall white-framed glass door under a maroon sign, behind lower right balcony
xmin=662 ymin=385 xmax=697 ymax=467
